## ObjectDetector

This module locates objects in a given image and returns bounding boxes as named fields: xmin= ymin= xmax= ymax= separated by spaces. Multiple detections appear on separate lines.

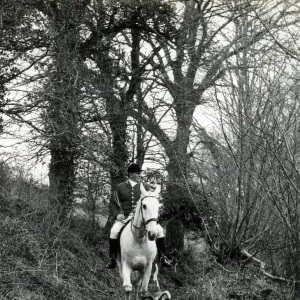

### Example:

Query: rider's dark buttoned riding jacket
xmin=111 ymin=180 xmax=150 ymax=220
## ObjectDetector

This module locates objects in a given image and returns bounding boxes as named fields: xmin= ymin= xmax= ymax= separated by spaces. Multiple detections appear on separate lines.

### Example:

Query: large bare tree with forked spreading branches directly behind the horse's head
xmin=126 ymin=1 xmax=295 ymax=253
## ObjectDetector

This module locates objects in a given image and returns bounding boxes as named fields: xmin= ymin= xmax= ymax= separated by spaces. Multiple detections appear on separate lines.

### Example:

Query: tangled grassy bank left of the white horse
xmin=0 ymin=193 xmax=119 ymax=300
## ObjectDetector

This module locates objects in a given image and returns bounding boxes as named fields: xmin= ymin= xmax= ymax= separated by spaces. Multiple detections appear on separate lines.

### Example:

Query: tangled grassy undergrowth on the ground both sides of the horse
xmin=0 ymin=170 xmax=291 ymax=300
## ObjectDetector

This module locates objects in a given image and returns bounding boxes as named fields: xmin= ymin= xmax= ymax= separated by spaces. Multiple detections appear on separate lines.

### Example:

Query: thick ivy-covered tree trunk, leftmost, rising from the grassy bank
xmin=44 ymin=1 xmax=84 ymax=221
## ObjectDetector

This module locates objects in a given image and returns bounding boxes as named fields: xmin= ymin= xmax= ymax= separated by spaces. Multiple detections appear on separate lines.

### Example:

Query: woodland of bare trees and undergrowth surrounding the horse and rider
xmin=0 ymin=0 xmax=300 ymax=299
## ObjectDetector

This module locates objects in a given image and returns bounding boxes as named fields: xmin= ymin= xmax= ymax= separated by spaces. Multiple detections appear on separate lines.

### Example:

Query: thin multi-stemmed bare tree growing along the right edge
xmin=199 ymin=2 xmax=299 ymax=299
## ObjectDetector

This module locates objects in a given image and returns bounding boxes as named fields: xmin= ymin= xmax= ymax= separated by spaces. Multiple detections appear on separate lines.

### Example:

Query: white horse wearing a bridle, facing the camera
xmin=117 ymin=185 xmax=160 ymax=300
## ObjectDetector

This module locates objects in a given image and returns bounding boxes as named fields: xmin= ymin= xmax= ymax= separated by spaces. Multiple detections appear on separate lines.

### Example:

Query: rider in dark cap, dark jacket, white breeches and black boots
xmin=106 ymin=164 xmax=172 ymax=269
